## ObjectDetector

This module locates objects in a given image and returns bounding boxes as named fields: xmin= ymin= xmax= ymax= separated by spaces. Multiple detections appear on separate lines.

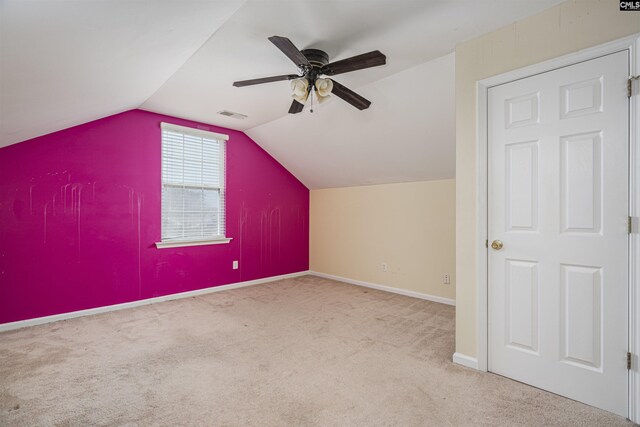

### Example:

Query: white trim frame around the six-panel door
xmin=476 ymin=33 xmax=640 ymax=423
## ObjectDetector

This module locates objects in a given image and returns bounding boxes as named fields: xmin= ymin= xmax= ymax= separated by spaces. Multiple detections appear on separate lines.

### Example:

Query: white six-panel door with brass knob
xmin=488 ymin=51 xmax=629 ymax=416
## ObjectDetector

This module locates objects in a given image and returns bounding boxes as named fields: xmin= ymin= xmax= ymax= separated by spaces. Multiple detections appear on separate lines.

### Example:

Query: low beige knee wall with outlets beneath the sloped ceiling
xmin=310 ymin=179 xmax=455 ymax=299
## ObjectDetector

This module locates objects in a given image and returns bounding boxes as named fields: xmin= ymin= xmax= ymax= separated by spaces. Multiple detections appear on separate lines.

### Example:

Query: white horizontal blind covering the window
xmin=161 ymin=123 xmax=228 ymax=242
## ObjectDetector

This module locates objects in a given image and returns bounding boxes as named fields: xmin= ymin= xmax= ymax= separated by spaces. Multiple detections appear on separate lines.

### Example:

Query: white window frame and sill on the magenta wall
xmin=156 ymin=122 xmax=232 ymax=249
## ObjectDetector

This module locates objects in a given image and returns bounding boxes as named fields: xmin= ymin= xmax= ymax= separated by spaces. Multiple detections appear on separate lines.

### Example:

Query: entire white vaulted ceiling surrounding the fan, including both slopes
xmin=0 ymin=0 xmax=560 ymax=188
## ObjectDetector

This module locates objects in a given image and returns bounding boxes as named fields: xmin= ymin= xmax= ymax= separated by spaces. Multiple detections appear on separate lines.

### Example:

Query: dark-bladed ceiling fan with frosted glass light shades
xmin=233 ymin=36 xmax=387 ymax=114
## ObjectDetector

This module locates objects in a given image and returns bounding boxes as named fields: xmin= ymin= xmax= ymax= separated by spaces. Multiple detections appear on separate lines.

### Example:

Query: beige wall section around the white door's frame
xmin=456 ymin=0 xmax=640 ymax=357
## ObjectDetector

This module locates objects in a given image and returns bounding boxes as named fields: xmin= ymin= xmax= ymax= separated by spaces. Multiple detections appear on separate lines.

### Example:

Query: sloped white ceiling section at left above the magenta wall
xmin=0 ymin=0 xmax=242 ymax=147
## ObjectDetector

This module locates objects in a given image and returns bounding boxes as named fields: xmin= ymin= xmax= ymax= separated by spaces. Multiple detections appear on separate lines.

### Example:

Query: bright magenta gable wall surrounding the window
xmin=0 ymin=110 xmax=309 ymax=323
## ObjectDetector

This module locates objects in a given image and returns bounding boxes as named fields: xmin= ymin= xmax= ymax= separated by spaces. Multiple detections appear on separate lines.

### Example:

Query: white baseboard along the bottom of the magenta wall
xmin=0 ymin=270 xmax=309 ymax=332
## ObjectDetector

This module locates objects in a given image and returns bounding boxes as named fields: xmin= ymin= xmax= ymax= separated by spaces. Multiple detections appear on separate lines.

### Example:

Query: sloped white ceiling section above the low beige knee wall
xmin=246 ymin=53 xmax=456 ymax=188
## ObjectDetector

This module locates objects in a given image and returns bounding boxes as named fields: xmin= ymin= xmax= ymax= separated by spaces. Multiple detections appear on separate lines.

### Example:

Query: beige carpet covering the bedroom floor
xmin=0 ymin=276 xmax=631 ymax=426
